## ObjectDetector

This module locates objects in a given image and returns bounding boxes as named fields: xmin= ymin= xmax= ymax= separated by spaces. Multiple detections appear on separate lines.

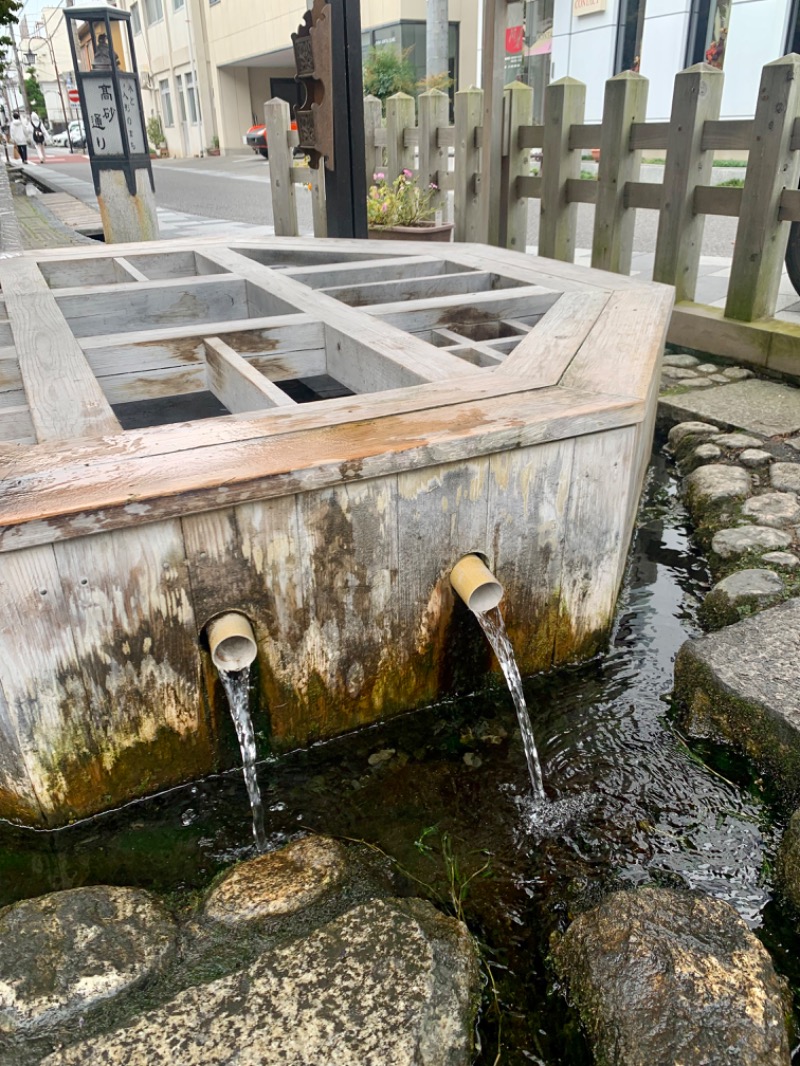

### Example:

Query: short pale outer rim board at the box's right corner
xmin=561 ymin=286 xmax=673 ymax=400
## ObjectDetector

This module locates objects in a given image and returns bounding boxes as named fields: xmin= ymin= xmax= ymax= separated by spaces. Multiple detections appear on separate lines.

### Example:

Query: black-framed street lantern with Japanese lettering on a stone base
xmin=63 ymin=4 xmax=158 ymax=242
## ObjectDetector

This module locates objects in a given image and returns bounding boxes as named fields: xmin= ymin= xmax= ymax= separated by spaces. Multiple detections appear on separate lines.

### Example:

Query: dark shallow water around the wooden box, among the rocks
xmin=0 ymin=445 xmax=796 ymax=1066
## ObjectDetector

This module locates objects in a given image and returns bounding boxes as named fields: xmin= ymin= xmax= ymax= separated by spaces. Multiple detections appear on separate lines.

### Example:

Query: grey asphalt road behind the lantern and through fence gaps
xmin=34 ymin=152 xmax=737 ymax=258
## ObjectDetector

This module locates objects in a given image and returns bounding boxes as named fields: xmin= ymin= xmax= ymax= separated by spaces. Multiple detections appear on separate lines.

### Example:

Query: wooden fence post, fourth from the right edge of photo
xmin=539 ymin=78 xmax=586 ymax=262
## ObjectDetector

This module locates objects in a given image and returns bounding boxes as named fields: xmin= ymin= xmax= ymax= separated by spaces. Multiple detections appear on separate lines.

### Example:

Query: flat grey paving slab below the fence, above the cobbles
xmin=659 ymin=378 xmax=800 ymax=437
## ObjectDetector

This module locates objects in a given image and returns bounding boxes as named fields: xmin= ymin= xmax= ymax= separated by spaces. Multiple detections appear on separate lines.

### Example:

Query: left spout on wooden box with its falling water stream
xmin=207 ymin=611 xmax=267 ymax=852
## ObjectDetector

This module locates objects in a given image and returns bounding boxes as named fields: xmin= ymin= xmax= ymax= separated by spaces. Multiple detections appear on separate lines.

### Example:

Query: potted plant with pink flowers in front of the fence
xmin=367 ymin=171 xmax=453 ymax=241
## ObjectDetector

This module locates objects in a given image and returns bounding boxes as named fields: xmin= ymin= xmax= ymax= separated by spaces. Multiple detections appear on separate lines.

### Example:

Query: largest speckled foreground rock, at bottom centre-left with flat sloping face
xmin=43 ymin=900 xmax=479 ymax=1066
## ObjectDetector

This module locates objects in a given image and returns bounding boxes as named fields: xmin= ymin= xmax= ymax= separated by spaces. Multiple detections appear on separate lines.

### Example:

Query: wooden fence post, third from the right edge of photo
xmin=592 ymin=70 xmax=647 ymax=274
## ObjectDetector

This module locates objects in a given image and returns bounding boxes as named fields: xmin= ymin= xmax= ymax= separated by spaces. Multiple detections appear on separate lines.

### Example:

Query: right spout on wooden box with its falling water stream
xmin=450 ymin=554 xmax=547 ymax=803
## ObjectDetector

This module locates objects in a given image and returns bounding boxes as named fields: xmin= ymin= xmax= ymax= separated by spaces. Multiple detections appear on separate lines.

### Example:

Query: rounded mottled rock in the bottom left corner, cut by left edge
xmin=0 ymin=886 xmax=176 ymax=1033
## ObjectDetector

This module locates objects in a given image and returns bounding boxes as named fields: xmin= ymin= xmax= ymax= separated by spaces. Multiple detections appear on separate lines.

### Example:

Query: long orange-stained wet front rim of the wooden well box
xmin=0 ymin=385 xmax=644 ymax=551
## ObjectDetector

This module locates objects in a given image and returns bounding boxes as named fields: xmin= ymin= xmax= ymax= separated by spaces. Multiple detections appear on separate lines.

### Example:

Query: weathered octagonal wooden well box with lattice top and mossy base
xmin=0 ymin=239 xmax=672 ymax=825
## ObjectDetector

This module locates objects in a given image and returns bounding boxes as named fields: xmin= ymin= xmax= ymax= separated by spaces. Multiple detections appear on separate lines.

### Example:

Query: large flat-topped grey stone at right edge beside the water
xmin=675 ymin=599 xmax=800 ymax=802
